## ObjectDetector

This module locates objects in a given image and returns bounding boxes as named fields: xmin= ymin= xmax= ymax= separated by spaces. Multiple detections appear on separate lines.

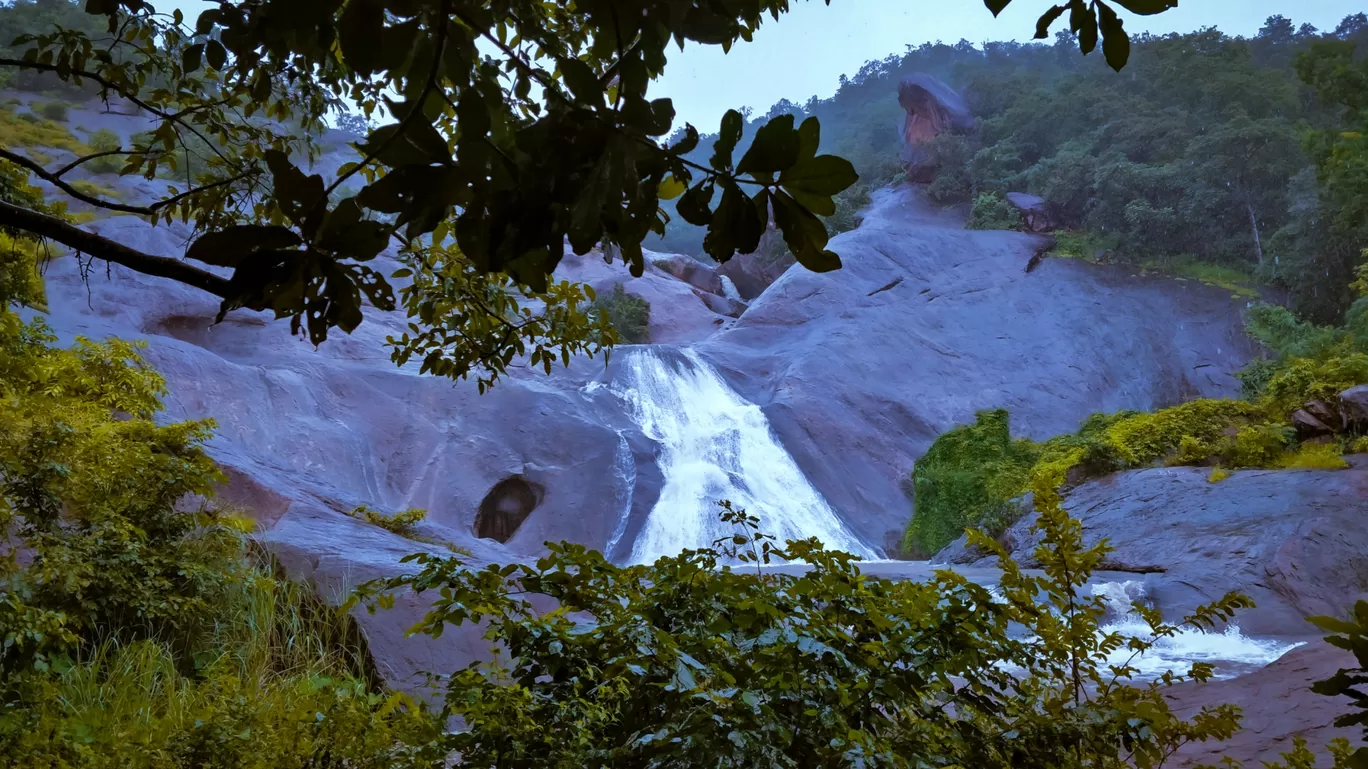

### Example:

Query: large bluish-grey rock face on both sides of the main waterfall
xmin=34 ymin=189 xmax=1246 ymax=687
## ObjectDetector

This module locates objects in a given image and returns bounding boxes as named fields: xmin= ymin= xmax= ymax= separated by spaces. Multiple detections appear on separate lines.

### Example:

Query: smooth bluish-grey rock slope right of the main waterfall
xmin=695 ymin=187 xmax=1252 ymax=551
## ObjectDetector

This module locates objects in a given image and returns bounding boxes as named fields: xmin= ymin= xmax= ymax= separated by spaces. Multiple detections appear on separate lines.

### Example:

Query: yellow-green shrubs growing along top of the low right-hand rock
xmin=903 ymin=271 xmax=1368 ymax=556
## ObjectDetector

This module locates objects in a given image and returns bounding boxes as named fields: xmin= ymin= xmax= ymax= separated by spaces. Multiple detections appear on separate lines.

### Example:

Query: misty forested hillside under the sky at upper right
xmin=655 ymin=14 xmax=1368 ymax=320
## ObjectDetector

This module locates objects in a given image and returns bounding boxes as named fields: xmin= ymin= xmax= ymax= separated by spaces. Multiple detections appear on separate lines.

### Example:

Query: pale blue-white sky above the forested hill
xmin=168 ymin=0 xmax=1365 ymax=133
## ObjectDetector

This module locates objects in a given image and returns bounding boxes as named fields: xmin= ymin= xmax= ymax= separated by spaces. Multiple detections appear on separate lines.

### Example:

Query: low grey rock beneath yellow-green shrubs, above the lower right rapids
xmin=936 ymin=456 xmax=1368 ymax=636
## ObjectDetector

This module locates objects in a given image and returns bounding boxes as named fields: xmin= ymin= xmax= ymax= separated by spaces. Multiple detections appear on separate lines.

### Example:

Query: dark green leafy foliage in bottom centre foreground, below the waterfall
xmin=363 ymin=489 xmax=1248 ymax=769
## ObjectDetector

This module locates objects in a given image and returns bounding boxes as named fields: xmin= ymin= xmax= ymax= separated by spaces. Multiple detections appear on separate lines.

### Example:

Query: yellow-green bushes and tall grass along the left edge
xmin=0 ymin=250 xmax=440 ymax=769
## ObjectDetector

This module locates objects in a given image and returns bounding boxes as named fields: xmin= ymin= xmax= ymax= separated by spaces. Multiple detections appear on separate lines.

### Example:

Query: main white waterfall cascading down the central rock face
xmin=613 ymin=349 xmax=876 ymax=564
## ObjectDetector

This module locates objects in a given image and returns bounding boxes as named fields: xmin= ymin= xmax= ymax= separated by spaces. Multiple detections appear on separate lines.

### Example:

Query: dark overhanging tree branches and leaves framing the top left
xmin=0 ymin=0 xmax=1174 ymax=385
